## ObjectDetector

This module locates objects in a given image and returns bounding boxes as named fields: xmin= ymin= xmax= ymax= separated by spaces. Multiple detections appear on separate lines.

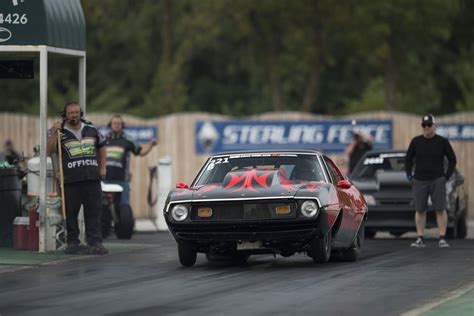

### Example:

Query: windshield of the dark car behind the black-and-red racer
xmin=351 ymin=153 xmax=405 ymax=179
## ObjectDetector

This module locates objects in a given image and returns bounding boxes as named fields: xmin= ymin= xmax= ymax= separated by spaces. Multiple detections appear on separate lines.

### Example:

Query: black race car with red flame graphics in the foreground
xmin=164 ymin=150 xmax=367 ymax=266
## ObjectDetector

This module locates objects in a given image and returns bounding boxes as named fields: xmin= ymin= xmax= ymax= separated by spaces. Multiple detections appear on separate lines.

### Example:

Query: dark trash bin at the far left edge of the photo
xmin=0 ymin=167 xmax=21 ymax=247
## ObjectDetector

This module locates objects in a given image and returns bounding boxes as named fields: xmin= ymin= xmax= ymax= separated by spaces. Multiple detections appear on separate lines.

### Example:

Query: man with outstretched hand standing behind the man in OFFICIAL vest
xmin=105 ymin=114 xmax=158 ymax=204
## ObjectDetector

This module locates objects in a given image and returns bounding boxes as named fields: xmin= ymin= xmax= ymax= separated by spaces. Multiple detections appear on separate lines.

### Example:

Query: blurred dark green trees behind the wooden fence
xmin=0 ymin=0 xmax=474 ymax=117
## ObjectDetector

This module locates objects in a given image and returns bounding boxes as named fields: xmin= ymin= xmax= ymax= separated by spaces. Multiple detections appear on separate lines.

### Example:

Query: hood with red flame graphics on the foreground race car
xmin=167 ymin=169 xmax=327 ymax=202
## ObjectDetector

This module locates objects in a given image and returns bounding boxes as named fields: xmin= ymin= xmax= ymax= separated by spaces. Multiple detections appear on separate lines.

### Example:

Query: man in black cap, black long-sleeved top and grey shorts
xmin=405 ymin=114 xmax=456 ymax=248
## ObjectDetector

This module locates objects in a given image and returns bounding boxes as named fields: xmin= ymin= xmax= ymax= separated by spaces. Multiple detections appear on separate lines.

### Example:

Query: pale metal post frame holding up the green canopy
xmin=0 ymin=45 xmax=86 ymax=252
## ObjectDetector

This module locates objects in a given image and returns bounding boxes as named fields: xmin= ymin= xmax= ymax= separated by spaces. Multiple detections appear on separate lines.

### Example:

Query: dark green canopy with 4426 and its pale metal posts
xmin=0 ymin=0 xmax=86 ymax=252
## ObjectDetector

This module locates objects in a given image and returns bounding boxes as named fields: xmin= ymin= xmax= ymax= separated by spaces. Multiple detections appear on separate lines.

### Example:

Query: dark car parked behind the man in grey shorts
xmin=350 ymin=151 xmax=468 ymax=238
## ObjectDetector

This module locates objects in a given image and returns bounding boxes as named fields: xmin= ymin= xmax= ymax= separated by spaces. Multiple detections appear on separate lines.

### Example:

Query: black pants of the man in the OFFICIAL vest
xmin=64 ymin=180 xmax=102 ymax=246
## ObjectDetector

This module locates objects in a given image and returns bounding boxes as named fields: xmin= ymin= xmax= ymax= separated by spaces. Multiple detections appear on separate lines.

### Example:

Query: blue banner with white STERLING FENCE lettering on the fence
xmin=195 ymin=120 xmax=392 ymax=154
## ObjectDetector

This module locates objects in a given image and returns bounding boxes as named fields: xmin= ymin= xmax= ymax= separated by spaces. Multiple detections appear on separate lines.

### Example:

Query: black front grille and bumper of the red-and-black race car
xmin=165 ymin=198 xmax=325 ymax=243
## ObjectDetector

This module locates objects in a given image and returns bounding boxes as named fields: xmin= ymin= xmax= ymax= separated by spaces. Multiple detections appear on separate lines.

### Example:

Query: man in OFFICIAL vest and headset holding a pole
xmin=48 ymin=102 xmax=108 ymax=255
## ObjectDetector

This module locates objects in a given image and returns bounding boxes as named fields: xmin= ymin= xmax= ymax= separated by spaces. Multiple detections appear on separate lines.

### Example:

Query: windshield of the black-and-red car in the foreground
xmin=194 ymin=153 xmax=325 ymax=185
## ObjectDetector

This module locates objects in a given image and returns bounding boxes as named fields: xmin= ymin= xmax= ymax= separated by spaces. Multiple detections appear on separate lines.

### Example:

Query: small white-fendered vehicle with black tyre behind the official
xmin=100 ymin=182 xmax=135 ymax=239
